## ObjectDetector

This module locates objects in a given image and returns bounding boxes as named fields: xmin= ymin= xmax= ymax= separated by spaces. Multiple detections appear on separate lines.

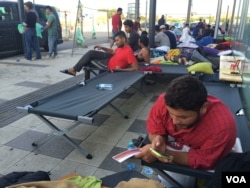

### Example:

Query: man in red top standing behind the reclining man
xmin=110 ymin=8 xmax=122 ymax=48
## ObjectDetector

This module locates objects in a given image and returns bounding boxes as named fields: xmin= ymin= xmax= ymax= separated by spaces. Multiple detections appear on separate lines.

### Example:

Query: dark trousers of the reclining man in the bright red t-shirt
xmin=73 ymin=50 xmax=112 ymax=72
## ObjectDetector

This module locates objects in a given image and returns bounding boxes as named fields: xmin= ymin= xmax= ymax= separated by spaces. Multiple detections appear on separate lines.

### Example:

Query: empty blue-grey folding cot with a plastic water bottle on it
xmin=17 ymin=72 xmax=144 ymax=159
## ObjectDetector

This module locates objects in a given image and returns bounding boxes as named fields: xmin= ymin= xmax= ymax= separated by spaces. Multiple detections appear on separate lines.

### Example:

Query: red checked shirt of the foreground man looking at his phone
xmin=147 ymin=94 xmax=236 ymax=169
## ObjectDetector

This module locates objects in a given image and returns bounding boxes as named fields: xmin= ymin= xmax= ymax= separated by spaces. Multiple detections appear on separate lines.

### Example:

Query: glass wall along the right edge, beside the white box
xmin=225 ymin=0 xmax=250 ymax=122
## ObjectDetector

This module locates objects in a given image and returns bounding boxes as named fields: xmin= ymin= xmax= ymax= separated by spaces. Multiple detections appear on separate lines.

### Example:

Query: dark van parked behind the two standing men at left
xmin=0 ymin=1 xmax=63 ymax=59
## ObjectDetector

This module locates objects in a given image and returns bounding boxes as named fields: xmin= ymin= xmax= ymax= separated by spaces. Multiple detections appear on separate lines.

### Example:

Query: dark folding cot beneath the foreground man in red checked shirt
xmin=142 ymin=82 xmax=250 ymax=187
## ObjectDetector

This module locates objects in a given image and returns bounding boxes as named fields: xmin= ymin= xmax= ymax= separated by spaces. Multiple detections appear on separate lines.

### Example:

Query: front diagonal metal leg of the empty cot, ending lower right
xmin=36 ymin=115 xmax=93 ymax=159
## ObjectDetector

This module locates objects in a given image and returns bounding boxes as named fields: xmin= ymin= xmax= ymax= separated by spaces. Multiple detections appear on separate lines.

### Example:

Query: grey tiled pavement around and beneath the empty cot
xmin=0 ymin=44 xmax=176 ymax=182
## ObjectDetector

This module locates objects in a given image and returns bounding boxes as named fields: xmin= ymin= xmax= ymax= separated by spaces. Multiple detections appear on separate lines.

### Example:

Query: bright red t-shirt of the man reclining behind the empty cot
xmin=108 ymin=45 xmax=137 ymax=70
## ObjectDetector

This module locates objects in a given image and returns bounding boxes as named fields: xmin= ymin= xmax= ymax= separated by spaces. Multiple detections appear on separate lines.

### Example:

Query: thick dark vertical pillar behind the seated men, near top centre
xmin=149 ymin=0 xmax=156 ymax=48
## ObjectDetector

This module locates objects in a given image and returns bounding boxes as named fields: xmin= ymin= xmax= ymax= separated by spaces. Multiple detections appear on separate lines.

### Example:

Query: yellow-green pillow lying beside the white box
xmin=187 ymin=62 xmax=214 ymax=74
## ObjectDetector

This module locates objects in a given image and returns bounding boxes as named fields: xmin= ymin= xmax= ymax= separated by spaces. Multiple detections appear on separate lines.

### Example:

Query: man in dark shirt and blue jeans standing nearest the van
xmin=23 ymin=1 xmax=41 ymax=61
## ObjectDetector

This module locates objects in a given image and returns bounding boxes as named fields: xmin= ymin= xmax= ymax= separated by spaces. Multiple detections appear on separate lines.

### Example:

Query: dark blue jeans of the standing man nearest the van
xmin=25 ymin=28 xmax=41 ymax=60
